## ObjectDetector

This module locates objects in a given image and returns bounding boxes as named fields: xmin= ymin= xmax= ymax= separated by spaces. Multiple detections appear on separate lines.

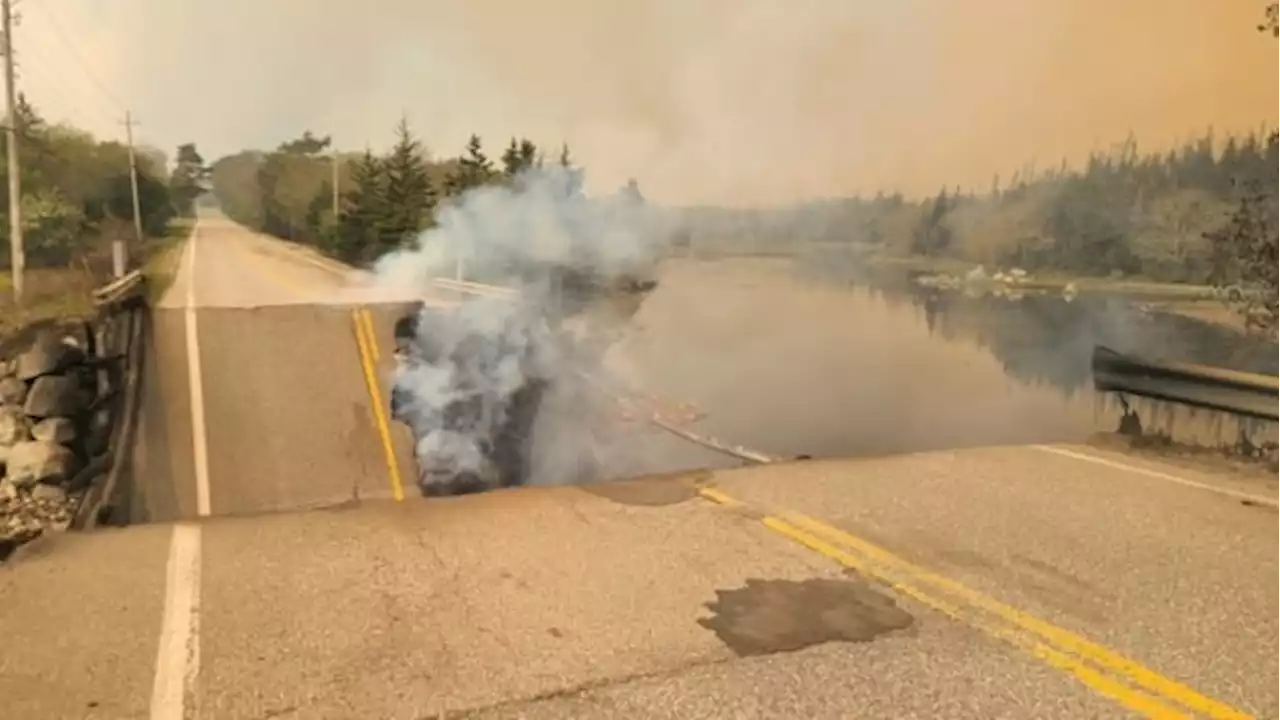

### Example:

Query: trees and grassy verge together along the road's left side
xmin=0 ymin=99 xmax=205 ymax=334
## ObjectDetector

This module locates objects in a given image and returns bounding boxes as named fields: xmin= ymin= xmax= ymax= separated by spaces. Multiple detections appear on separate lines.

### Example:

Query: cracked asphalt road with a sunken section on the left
xmin=0 ymin=218 xmax=1280 ymax=720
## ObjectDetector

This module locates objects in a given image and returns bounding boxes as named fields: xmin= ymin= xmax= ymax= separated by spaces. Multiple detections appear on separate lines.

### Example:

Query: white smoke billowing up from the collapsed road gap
xmin=374 ymin=167 xmax=669 ymax=492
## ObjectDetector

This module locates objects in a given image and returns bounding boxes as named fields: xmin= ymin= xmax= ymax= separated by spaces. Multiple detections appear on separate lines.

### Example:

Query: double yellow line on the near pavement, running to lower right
xmin=699 ymin=487 xmax=1252 ymax=720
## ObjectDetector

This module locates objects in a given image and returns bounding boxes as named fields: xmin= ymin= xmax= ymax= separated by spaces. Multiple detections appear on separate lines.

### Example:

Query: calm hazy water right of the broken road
xmin=612 ymin=252 xmax=1280 ymax=456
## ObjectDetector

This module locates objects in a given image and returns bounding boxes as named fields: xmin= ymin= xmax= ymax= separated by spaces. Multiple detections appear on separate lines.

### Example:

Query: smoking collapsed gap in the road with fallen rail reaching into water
xmin=390 ymin=266 xmax=803 ymax=497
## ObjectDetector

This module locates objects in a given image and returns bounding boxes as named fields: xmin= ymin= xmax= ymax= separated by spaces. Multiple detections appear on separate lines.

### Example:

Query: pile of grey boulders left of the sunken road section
xmin=0 ymin=331 xmax=111 ymax=560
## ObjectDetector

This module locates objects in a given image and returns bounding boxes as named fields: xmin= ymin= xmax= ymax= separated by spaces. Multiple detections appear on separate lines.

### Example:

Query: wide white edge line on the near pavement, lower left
xmin=150 ymin=524 xmax=200 ymax=720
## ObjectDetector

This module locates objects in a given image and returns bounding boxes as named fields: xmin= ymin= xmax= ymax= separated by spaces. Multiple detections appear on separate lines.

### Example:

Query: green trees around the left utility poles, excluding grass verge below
xmin=0 ymin=96 xmax=202 ymax=268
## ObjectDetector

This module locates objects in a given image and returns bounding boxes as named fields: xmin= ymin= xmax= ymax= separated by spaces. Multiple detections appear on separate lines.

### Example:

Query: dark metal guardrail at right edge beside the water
xmin=1093 ymin=346 xmax=1280 ymax=420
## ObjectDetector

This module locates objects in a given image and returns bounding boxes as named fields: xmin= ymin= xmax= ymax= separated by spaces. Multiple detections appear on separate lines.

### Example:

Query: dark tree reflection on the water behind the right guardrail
xmin=800 ymin=252 xmax=1280 ymax=447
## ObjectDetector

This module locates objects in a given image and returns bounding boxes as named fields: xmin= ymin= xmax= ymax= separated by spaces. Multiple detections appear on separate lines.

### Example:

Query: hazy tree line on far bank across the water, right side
xmin=686 ymin=131 xmax=1280 ymax=283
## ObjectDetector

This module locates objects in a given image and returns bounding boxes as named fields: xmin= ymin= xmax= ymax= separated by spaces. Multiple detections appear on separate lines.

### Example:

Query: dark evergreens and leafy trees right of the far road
xmin=210 ymin=119 xmax=573 ymax=264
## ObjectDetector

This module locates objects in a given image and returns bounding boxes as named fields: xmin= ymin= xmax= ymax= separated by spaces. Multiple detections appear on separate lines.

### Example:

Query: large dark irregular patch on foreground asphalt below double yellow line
xmin=698 ymin=578 xmax=915 ymax=657
